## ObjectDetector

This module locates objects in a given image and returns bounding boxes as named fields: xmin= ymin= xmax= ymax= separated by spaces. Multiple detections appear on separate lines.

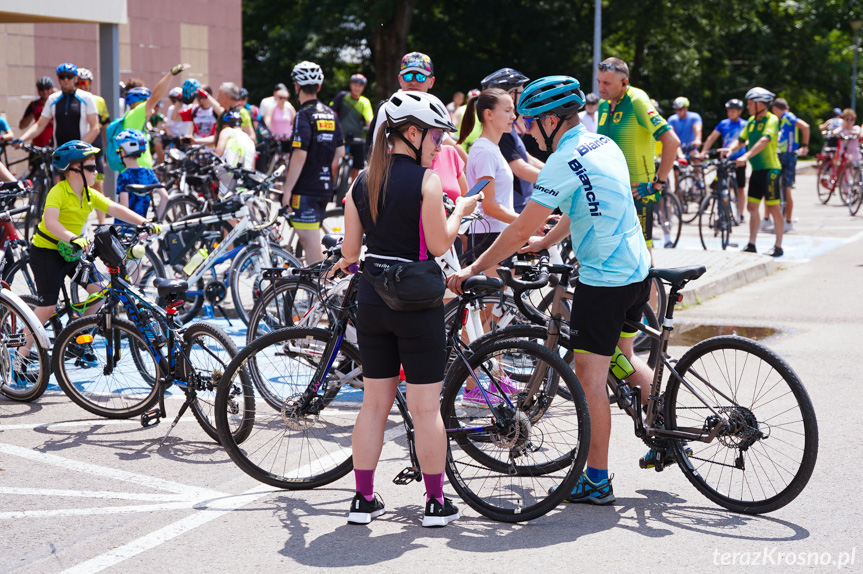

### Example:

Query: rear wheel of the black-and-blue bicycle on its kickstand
xmin=183 ymin=323 xmax=255 ymax=443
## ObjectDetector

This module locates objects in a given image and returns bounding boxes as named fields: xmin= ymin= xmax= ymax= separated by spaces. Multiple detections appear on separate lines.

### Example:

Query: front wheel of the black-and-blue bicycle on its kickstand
xmin=51 ymin=315 xmax=161 ymax=419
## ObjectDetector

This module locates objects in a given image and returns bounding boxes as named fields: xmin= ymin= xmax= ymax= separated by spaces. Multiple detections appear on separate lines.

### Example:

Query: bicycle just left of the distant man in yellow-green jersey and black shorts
xmin=698 ymin=159 xmax=740 ymax=251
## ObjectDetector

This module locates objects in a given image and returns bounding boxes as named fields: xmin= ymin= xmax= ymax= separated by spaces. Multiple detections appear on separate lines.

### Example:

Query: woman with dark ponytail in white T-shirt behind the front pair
xmin=458 ymin=88 xmax=518 ymax=275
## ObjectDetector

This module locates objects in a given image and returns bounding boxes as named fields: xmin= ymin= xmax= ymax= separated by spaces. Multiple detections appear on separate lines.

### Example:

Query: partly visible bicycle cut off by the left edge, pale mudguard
xmin=0 ymin=206 xmax=51 ymax=401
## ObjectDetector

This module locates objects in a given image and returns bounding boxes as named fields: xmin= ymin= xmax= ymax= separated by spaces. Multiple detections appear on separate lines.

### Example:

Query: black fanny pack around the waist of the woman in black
xmin=363 ymin=255 xmax=446 ymax=311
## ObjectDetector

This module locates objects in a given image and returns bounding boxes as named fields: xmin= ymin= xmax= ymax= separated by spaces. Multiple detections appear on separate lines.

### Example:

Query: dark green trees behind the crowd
xmin=243 ymin=0 xmax=863 ymax=146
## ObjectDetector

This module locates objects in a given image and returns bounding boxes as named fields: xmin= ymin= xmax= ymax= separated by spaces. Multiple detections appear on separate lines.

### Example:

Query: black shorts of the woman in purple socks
xmin=357 ymin=303 xmax=446 ymax=385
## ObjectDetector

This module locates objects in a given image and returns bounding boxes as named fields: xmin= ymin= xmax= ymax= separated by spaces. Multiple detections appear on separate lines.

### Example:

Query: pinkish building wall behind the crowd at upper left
xmin=0 ymin=0 xmax=243 ymax=166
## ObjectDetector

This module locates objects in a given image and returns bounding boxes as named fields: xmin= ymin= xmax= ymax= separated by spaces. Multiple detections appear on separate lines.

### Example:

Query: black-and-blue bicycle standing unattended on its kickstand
xmin=51 ymin=226 xmax=252 ymax=442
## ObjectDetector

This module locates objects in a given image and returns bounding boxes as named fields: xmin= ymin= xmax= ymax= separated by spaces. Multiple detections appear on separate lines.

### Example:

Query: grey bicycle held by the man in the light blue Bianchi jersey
xmin=486 ymin=258 xmax=818 ymax=514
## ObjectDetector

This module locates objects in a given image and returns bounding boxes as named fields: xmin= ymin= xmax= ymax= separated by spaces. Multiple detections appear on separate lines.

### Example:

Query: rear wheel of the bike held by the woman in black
xmin=441 ymin=340 xmax=590 ymax=522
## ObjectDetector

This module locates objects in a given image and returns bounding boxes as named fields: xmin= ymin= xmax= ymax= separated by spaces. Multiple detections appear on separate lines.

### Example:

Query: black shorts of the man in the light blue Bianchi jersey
xmin=570 ymin=279 xmax=650 ymax=357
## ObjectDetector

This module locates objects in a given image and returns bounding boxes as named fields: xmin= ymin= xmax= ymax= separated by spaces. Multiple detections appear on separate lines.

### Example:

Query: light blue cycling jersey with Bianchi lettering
xmin=531 ymin=124 xmax=650 ymax=287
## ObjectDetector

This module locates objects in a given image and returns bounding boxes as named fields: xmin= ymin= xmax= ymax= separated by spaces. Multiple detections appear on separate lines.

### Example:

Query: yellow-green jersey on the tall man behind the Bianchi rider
xmin=596 ymin=86 xmax=671 ymax=185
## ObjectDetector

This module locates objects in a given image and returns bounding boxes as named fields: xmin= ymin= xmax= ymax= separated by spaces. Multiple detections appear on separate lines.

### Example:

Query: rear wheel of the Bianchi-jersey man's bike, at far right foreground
xmin=665 ymin=336 xmax=818 ymax=514
